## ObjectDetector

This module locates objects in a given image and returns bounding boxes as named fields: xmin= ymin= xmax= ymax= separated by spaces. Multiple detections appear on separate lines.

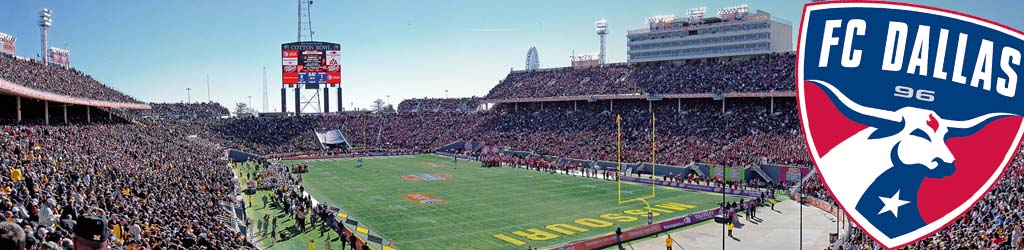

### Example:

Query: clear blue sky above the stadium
xmin=0 ymin=0 xmax=1024 ymax=111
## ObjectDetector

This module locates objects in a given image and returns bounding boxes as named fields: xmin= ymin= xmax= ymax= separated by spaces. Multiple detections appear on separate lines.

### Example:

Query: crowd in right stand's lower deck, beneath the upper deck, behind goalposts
xmin=473 ymin=99 xmax=810 ymax=166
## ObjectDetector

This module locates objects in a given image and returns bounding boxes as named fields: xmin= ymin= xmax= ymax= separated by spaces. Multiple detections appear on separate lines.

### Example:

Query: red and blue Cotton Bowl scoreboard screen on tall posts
xmin=281 ymin=42 xmax=341 ymax=86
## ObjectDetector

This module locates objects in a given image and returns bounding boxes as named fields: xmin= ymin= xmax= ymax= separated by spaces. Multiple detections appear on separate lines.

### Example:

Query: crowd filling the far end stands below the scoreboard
xmin=150 ymin=113 xmax=487 ymax=155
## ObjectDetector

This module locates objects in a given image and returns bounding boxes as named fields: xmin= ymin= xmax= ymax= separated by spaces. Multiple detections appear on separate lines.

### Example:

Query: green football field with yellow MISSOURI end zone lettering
xmin=285 ymin=155 xmax=738 ymax=250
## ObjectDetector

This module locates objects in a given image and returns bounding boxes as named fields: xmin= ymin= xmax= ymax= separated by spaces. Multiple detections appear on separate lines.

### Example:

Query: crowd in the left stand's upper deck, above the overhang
xmin=0 ymin=53 xmax=139 ymax=102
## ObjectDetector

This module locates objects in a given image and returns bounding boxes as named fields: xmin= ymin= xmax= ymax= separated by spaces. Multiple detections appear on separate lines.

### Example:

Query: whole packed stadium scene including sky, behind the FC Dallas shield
xmin=0 ymin=0 xmax=1024 ymax=250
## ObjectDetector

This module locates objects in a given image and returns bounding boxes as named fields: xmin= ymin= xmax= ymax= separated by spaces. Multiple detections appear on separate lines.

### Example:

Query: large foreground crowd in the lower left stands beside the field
xmin=0 ymin=124 xmax=251 ymax=249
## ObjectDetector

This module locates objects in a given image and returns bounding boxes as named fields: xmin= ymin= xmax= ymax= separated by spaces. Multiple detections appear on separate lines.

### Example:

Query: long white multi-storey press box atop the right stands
xmin=626 ymin=5 xmax=793 ymax=63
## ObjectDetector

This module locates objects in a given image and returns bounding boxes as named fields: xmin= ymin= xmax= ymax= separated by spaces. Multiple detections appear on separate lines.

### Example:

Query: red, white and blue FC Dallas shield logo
xmin=797 ymin=2 xmax=1024 ymax=248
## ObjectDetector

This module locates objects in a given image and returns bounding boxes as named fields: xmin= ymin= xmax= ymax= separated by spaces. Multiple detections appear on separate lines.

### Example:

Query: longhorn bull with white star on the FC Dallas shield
xmin=809 ymin=80 xmax=1013 ymax=237
